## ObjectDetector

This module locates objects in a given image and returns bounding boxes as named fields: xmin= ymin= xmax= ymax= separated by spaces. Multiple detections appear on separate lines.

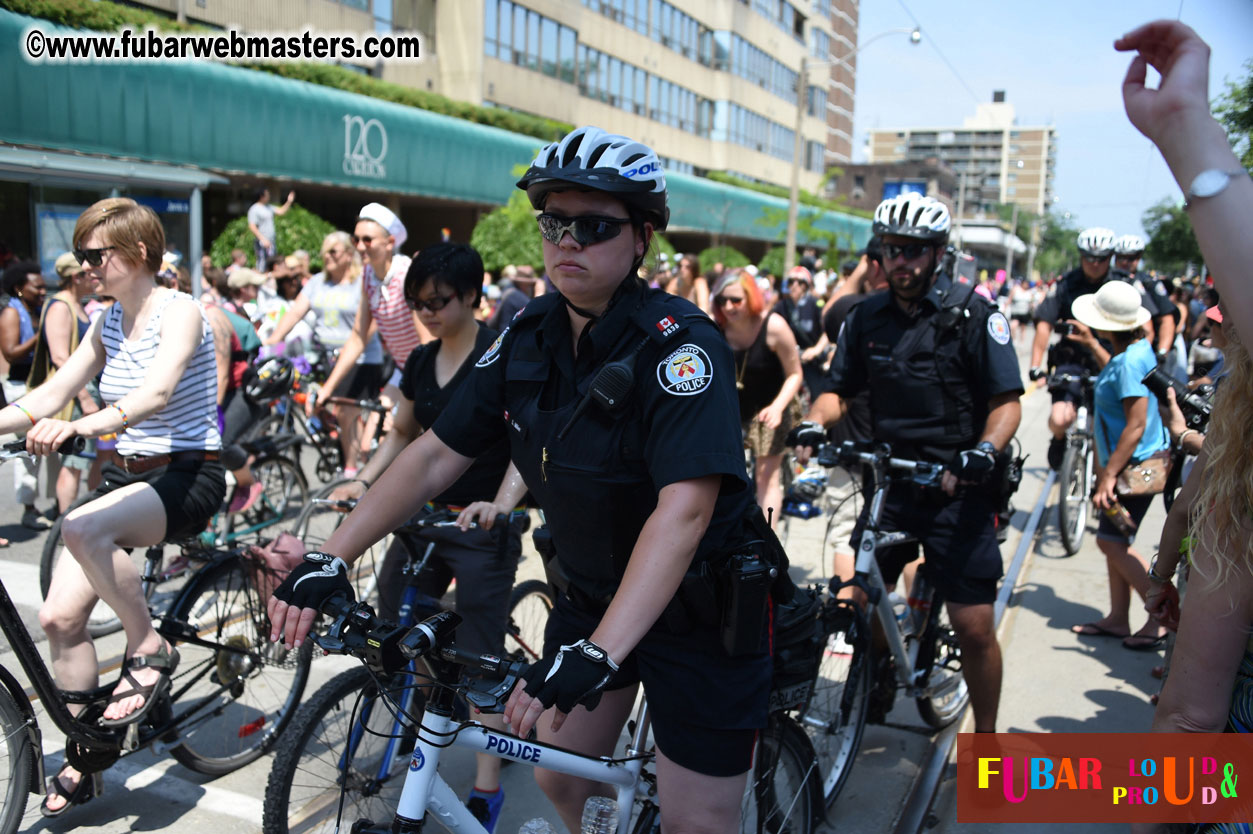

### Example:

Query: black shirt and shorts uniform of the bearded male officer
xmin=828 ymin=274 xmax=1022 ymax=604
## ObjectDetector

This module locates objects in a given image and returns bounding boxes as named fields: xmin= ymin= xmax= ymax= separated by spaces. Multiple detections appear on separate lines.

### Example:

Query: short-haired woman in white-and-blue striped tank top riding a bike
xmin=0 ymin=198 xmax=226 ymax=816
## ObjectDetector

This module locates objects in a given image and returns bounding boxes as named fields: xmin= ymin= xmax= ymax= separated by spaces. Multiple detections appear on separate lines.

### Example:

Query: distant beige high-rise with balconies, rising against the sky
xmin=867 ymin=90 xmax=1058 ymax=218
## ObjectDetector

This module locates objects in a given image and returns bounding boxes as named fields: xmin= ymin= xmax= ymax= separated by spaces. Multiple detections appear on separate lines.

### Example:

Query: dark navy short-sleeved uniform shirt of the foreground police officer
xmin=432 ymin=278 xmax=752 ymax=597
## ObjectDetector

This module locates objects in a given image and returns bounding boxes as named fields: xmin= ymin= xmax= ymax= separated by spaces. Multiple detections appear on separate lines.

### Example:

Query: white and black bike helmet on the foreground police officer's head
xmin=517 ymin=126 xmax=670 ymax=232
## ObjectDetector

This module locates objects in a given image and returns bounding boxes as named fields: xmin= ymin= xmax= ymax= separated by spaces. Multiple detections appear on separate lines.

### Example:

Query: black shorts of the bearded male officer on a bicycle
xmin=848 ymin=483 xmax=1004 ymax=605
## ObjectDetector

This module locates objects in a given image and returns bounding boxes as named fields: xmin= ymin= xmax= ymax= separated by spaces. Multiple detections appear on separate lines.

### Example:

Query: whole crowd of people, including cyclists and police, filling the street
xmin=0 ymin=14 xmax=1253 ymax=831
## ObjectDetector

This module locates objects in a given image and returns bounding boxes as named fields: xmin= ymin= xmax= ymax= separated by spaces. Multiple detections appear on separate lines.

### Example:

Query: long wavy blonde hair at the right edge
xmin=1188 ymin=327 xmax=1253 ymax=586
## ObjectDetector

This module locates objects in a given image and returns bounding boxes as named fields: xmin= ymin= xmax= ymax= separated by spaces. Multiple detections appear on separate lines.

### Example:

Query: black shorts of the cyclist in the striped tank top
xmin=83 ymin=461 xmax=227 ymax=541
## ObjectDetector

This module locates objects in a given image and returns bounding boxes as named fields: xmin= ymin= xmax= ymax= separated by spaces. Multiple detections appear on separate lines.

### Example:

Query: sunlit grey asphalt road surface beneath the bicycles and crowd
xmin=0 ymin=328 xmax=1163 ymax=834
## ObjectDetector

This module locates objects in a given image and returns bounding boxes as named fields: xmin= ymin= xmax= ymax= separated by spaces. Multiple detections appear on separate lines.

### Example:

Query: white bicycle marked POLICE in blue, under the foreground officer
xmin=263 ymin=597 xmax=821 ymax=834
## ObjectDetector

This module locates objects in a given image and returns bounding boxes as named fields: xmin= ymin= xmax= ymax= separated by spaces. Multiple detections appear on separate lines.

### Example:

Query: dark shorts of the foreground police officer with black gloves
xmin=544 ymin=595 xmax=773 ymax=776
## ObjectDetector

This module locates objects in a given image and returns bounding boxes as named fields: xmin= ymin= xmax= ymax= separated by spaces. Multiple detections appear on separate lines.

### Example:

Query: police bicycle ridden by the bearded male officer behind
xmin=798 ymin=441 xmax=970 ymax=808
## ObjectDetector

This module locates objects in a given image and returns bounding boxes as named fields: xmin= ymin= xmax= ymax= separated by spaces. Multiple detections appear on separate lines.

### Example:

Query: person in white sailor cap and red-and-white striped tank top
xmin=306 ymin=203 xmax=431 ymax=435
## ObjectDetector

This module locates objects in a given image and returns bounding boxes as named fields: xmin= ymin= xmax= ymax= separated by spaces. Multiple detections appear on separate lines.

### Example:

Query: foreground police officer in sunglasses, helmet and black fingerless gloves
xmin=271 ymin=128 xmax=771 ymax=831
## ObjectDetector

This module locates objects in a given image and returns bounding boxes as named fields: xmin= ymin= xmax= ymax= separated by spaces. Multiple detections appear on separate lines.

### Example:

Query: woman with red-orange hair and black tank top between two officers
xmin=713 ymin=269 xmax=803 ymax=521
